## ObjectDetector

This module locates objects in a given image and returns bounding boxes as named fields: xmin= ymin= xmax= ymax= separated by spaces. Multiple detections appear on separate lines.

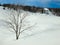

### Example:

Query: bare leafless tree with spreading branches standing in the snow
xmin=3 ymin=10 xmax=35 ymax=40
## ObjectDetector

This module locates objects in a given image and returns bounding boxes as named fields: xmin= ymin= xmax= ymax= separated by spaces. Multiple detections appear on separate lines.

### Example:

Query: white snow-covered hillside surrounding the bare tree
xmin=0 ymin=6 xmax=60 ymax=45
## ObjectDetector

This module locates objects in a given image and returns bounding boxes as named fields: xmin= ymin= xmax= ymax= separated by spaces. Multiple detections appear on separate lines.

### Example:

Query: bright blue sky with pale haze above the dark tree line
xmin=0 ymin=0 xmax=60 ymax=8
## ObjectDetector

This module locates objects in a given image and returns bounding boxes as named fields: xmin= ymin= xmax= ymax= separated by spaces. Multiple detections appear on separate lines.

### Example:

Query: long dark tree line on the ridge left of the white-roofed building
xmin=2 ymin=4 xmax=44 ymax=13
